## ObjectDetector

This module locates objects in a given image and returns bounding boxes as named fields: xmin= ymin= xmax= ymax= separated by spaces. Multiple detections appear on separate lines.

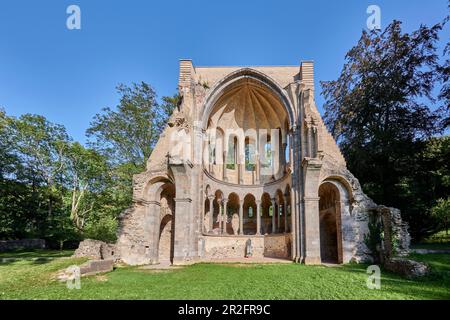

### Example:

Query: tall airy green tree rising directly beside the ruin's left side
xmin=87 ymin=82 xmax=180 ymax=222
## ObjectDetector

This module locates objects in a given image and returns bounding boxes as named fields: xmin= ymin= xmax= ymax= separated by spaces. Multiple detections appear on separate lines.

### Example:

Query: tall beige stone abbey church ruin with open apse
xmin=115 ymin=60 xmax=408 ymax=265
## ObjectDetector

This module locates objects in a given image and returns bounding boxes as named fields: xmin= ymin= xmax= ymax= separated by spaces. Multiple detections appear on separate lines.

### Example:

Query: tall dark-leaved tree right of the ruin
xmin=321 ymin=21 xmax=442 ymax=239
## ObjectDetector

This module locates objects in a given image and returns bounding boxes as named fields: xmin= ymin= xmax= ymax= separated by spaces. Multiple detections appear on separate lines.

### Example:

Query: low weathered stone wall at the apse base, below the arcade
xmin=201 ymin=236 xmax=264 ymax=260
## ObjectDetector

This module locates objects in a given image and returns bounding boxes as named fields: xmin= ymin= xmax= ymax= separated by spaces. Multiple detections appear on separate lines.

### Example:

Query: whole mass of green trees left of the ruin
xmin=0 ymin=83 xmax=176 ymax=248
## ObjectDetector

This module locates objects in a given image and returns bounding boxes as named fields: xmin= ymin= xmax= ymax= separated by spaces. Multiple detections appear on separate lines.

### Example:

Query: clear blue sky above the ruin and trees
xmin=0 ymin=0 xmax=450 ymax=142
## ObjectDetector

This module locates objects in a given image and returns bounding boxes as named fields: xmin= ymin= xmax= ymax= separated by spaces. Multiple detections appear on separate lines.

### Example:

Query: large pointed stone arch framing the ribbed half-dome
xmin=201 ymin=68 xmax=296 ymax=130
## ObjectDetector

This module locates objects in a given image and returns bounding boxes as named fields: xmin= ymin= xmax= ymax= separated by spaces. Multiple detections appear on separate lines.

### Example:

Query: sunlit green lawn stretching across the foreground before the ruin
xmin=0 ymin=252 xmax=450 ymax=299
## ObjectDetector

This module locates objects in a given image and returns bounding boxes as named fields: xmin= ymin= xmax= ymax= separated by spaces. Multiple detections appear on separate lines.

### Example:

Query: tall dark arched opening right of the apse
xmin=319 ymin=181 xmax=343 ymax=263
